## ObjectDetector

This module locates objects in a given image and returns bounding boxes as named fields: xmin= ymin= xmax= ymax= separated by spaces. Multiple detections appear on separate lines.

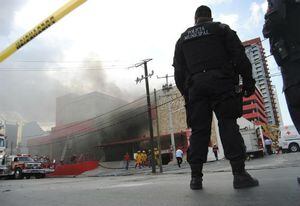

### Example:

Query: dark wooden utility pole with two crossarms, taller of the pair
xmin=135 ymin=59 xmax=156 ymax=173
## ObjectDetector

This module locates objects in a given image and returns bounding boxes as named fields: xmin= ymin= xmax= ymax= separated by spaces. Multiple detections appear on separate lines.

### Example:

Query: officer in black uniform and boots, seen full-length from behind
xmin=173 ymin=6 xmax=258 ymax=189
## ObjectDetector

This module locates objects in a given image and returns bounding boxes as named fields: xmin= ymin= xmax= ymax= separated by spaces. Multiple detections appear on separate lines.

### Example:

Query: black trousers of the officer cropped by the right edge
xmin=285 ymin=84 xmax=300 ymax=133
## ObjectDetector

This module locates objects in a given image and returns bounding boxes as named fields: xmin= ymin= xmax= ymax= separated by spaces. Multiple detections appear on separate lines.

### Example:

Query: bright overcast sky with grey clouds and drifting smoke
xmin=0 ymin=0 xmax=292 ymax=128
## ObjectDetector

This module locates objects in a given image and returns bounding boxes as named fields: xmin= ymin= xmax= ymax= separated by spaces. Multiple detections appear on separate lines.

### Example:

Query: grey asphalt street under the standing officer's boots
xmin=0 ymin=153 xmax=300 ymax=206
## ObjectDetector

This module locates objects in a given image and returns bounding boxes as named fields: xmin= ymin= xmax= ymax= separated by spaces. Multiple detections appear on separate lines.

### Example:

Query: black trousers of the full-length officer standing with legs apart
xmin=188 ymin=71 xmax=245 ymax=165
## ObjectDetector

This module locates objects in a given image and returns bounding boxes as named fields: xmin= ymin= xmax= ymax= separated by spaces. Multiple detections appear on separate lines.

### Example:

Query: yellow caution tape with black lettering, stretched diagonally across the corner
xmin=0 ymin=0 xmax=87 ymax=62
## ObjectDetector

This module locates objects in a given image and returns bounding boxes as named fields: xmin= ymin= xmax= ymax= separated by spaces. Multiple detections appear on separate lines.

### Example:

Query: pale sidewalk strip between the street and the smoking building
xmin=77 ymin=154 xmax=300 ymax=177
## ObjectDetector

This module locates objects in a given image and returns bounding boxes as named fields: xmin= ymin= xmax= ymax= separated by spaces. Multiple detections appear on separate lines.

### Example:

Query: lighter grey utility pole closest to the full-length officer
xmin=157 ymin=74 xmax=176 ymax=160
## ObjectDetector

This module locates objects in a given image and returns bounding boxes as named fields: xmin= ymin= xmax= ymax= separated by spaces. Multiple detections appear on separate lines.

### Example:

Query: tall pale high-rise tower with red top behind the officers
xmin=243 ymin=38 xmax=280 ymax=126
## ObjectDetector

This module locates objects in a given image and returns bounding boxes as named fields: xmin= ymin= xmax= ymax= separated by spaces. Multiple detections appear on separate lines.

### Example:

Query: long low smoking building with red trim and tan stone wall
xmin=28 ymin=88 xmax=266 ymax=163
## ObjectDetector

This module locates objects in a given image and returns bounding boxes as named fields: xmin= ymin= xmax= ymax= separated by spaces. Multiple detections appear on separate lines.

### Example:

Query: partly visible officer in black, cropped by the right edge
xmin=263 ymin=0 xmax=300 ymax=133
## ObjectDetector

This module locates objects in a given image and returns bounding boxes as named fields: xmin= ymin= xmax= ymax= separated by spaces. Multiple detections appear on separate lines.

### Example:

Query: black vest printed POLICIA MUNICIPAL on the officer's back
xmin=181 ymin=22 xmax=228 ymax=74
